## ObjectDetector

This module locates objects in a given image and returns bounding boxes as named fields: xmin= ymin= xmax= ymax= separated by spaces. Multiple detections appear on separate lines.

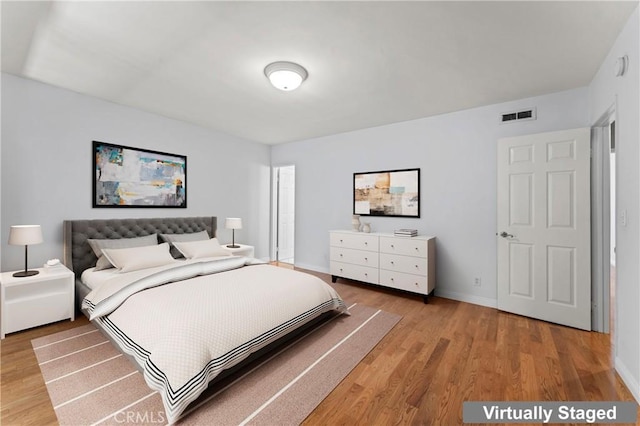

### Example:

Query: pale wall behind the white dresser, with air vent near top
xmin=272 ymin=88 xmax=588 ymax=306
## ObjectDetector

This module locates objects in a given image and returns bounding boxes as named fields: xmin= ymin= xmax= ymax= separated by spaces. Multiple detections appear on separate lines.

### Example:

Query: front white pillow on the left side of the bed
xmin=102 ymin=243 xmax=176 ymax=272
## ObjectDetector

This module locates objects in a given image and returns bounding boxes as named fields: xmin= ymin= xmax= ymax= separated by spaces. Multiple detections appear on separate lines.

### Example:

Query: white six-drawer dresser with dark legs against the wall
xmin=329 ymin=231 xmax=436 ymax=303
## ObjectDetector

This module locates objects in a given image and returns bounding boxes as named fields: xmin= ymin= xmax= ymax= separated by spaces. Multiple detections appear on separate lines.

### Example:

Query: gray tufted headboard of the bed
xmin=63 ymin=216 xmax=217 ymax=278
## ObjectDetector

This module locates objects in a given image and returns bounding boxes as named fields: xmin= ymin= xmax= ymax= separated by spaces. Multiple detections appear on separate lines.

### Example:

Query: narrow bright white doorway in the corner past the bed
xmin=272 ymin=165 xmax=296 ymax=265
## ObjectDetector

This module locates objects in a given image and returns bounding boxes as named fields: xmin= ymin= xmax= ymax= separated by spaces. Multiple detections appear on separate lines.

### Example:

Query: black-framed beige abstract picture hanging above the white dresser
xmin=353 ymin=168 xmax=420 ymax=218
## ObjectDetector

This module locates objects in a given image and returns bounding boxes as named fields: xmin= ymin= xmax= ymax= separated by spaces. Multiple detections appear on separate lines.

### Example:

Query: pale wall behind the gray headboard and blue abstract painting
xmin=0 ymin=73 xmax=270 ymax=271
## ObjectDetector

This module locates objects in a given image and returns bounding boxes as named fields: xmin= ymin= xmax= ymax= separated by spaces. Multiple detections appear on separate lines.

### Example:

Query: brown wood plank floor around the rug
xmin=0 ymin=273 xmax=640 ymax=425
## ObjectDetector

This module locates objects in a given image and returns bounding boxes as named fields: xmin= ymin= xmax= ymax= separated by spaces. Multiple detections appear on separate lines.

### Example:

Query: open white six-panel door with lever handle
xmin=498 ymin=128 xmax=591 ymax=330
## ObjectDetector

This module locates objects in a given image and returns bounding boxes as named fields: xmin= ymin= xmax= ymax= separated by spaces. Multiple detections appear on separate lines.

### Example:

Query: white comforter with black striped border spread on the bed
xmin=83 ymin=257 xmax=346 ymax=423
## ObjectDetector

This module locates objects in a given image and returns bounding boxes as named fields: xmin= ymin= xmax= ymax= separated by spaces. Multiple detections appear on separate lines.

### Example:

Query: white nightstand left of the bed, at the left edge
xmin=0 ymin=265 xmax=75 ymax=339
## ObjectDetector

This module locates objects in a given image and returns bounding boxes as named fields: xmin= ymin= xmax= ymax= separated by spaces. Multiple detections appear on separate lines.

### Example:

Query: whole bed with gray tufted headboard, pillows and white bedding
xmin=63 ymin=217 xmax=348 ymax=423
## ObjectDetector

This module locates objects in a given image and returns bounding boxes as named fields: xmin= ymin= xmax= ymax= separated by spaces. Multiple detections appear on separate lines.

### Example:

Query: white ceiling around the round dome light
xmin=2 ymin=0 xmax=638 ymax=144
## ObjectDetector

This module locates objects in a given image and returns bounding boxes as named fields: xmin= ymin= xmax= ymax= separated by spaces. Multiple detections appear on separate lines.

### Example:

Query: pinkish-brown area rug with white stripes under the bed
xmin=31 ymin=304 xmax=401 ymax=426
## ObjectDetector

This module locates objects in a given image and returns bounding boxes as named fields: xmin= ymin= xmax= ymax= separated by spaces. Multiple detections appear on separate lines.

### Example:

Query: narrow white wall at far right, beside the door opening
xmin=589 ymin=4 xmax=640 ymax=401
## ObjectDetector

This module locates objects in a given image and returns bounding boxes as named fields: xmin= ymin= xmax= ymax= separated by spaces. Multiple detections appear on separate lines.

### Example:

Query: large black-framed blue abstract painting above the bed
xmin=93 ymin=141 xmax=187 ymax=208
